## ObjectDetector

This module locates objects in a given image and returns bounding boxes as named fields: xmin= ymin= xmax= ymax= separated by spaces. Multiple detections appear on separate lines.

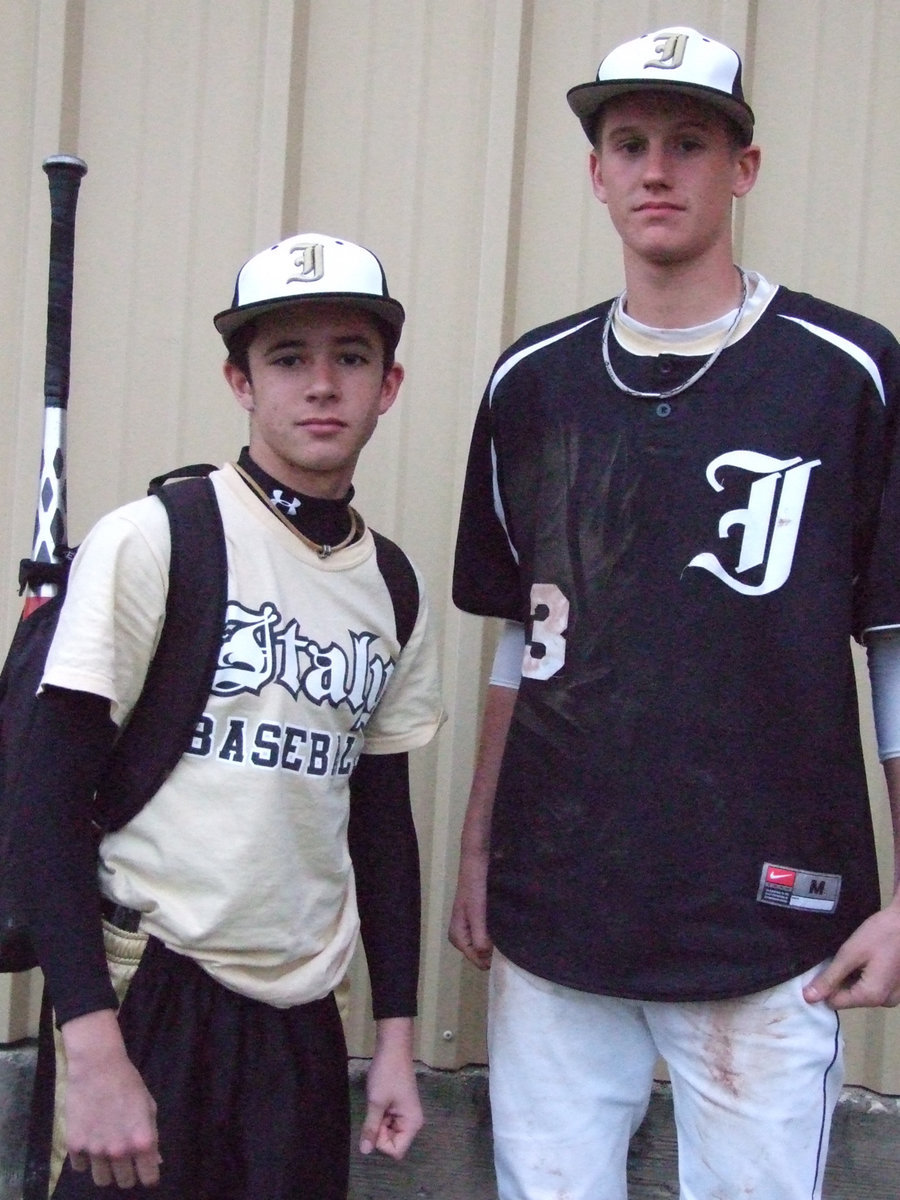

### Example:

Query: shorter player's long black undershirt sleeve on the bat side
xmin=18 ymin=688 xmax=118 ymax=1025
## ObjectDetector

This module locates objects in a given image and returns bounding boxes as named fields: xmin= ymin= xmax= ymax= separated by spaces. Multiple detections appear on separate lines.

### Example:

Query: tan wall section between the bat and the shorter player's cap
xmin=64 ymin=0 xmax=293 ymax=528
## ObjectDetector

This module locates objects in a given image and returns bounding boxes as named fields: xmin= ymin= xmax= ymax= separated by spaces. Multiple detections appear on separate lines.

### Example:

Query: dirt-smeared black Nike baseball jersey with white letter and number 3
xmin=454 ymin=277 xmax=900 ymax=1000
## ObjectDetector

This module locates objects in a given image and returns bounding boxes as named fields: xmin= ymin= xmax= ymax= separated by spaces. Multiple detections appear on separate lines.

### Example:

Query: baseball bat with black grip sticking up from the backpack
xmin=23 ymin=154 xmax=88 ymax=616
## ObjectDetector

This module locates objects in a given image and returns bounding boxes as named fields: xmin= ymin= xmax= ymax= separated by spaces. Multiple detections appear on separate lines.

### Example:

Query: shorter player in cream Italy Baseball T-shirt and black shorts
xmin=20 ymin=233 xmax=443 ymax=1200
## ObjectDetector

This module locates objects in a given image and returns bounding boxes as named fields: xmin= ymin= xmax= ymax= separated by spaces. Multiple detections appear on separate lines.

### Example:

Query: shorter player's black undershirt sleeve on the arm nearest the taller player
xmin=348 ymin=754 xmax=421 ymax=1020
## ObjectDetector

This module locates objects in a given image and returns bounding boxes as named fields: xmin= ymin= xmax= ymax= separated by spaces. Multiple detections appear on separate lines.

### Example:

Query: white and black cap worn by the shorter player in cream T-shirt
xmin=212 ymin=233 xmax=406 ymax=344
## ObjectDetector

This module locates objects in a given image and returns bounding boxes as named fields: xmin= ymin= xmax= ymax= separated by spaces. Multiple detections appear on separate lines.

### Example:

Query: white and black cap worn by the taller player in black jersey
xmin=566 ymin=25 xmax=754 ymax=145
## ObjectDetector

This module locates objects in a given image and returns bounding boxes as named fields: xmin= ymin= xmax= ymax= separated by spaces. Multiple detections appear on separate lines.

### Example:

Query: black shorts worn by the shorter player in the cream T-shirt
xmin=30 ymin=937 xmax=350 ymax=1200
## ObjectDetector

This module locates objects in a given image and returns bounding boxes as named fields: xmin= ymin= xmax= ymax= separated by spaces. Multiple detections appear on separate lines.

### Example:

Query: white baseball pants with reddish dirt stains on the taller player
xmin=488 ymin=950 xmax=844 ymax=1200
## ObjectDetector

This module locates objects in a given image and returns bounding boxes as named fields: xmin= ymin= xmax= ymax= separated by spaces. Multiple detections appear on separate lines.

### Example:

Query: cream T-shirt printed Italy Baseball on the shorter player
xmin=44 ymin=467 xmax=443 ymax=1007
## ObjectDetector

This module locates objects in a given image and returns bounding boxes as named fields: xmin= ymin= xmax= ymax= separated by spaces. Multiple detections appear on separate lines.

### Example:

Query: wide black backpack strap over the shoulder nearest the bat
xmin=97 ymin=467 xmax=228 ymax=829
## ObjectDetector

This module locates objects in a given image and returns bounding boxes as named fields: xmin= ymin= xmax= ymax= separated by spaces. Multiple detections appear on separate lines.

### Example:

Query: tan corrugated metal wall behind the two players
xmin=0 ymin=0 xmax=900 ymax=1092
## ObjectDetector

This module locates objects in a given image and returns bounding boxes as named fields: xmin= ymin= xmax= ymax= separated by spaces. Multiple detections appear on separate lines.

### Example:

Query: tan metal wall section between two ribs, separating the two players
xmin=282 ymin=2 xmax=528 ymax=1066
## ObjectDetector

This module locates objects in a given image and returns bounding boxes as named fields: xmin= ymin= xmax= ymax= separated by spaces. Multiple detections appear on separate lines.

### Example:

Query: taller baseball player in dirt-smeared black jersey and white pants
xmin=450 ymin=28 xmax=900 ymax=1200
